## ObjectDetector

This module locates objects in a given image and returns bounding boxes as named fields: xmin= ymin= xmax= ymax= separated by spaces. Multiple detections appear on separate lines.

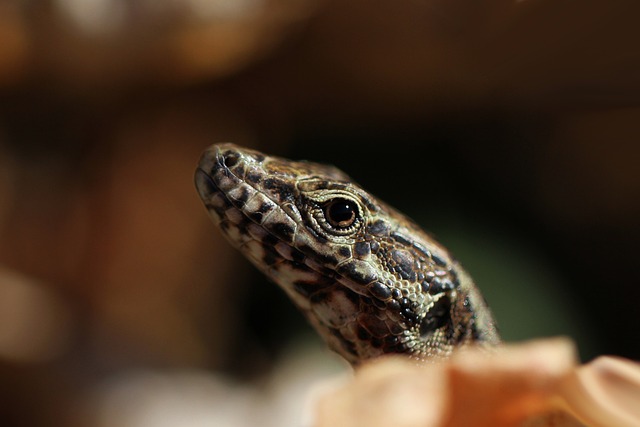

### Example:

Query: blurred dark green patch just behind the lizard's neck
xmin=436 ymin=216 xmax=601 ymax=360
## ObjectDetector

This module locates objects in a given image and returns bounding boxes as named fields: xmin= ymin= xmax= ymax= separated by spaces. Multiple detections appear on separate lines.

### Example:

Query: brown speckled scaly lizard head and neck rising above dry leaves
xmin=195 ymin=144 xmax=499 ymax=364
